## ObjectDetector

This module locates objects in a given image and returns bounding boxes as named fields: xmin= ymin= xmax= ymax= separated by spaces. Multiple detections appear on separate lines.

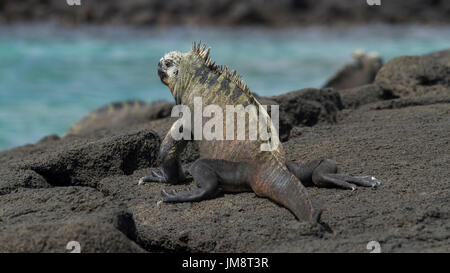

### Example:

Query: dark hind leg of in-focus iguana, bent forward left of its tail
xmin=161 ymin=158 xmax=251 ymax=202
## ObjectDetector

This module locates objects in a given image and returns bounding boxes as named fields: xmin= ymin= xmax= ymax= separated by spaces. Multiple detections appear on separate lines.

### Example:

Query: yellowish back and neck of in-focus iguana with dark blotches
xmin=174 ymin=44 xmax=286 ymax=166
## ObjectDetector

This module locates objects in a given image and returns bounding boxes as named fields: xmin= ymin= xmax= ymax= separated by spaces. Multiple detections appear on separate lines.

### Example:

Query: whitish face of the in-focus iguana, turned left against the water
xmin=158 ymin=51 xmax=184 ymax=89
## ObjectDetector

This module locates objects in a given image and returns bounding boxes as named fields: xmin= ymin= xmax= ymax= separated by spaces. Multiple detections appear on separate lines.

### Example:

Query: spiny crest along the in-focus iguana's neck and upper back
xmin=192 ymin=41 xmax=259 ymax=104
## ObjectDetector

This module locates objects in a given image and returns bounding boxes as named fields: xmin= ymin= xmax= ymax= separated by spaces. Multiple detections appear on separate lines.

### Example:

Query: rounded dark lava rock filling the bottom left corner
xmin=0 ymin=187 xmax=144 ymax=252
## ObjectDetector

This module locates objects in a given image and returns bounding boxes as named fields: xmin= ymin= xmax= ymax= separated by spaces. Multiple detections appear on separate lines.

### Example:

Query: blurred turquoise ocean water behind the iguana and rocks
xmin=0 ymin=24 xmax=450 ymax=150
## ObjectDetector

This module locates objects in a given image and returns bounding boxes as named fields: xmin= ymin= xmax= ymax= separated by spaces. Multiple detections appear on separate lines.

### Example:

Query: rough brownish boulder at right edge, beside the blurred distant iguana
xmin=339 ymin=50 xmax=450 ymax=109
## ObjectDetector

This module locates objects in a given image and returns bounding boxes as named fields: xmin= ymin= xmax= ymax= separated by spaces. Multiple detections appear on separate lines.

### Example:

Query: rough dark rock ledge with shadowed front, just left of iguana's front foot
xmin=19 ymin=130 xmax=160 ymax=187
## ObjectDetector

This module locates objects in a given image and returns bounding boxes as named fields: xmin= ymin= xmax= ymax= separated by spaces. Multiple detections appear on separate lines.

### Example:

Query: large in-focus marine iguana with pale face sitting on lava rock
xmin=139 ymin=43 xmax=381 ymax=222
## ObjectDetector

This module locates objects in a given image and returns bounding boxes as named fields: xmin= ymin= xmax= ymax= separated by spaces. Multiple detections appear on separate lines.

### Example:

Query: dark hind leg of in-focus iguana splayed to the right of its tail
xmin=286 ymin=159 xmax=381 ymax=191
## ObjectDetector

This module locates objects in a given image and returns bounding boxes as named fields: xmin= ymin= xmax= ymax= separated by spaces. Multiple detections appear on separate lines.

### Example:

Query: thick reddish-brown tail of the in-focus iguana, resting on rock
xmin=252 ymin=164 xmax=322 ymax=223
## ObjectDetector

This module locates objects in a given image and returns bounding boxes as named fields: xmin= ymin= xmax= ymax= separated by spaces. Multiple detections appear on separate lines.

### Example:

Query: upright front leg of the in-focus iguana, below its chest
xmin=139 ymin=127 xmax=188 ymax=184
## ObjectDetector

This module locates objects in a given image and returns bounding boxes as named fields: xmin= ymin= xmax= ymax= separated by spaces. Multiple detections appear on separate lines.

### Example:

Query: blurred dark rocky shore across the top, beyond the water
xmin=0 ymin=0 xmax=450 ymax=26
